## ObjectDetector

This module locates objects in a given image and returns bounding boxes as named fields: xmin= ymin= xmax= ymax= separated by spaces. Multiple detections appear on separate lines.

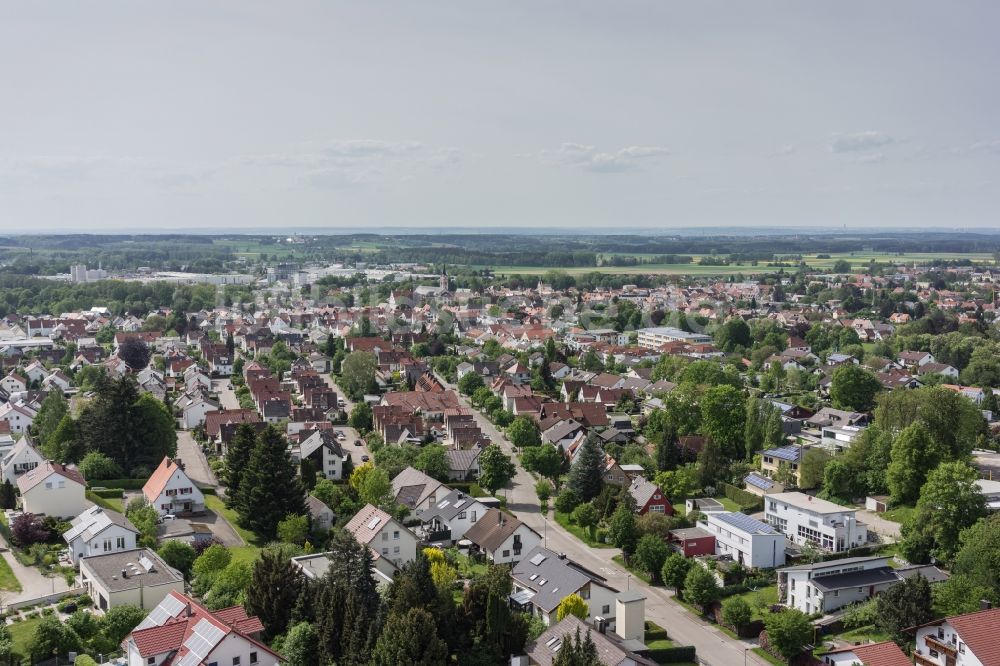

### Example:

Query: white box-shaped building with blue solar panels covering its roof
xmin=698 ymin=511 xmax=787 ymax=569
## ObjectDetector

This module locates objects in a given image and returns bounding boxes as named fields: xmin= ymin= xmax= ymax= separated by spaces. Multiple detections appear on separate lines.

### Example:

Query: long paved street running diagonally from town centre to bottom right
xmin=438 ymin=377 xmax=767 ymax=666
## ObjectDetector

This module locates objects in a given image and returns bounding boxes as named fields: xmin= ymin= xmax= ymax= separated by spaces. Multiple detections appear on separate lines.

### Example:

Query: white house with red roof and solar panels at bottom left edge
xmin=122 ymin=591 xmax=284 ymax=666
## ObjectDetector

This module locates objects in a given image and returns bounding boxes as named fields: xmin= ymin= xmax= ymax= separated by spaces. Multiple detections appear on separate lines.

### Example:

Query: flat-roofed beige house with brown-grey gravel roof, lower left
xmin=79 ymin=548 xmax=185 ymax=608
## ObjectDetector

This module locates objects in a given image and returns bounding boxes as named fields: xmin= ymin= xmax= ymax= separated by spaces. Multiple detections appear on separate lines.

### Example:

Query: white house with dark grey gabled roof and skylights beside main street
xmin=510 ymin=546 xmax=618 ymax=626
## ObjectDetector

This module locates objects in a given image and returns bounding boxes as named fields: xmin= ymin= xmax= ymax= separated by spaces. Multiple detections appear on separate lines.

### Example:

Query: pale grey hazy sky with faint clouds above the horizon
xmin=0 ymin=0 xmax=1000 ymax=233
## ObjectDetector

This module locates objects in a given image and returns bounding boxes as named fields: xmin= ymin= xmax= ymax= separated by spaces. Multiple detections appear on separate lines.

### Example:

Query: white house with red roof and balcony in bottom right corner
xmin=913 ymin=608 xmax=1000 ymax=666
